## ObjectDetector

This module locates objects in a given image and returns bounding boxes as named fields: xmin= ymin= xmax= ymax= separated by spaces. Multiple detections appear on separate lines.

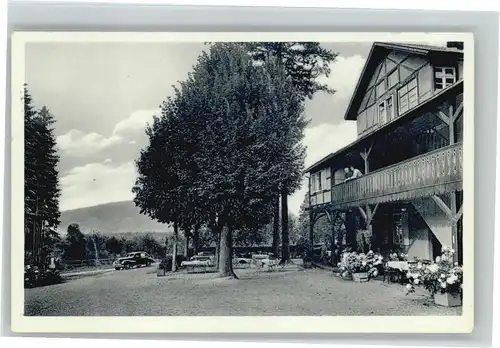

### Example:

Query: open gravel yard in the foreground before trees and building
xmin=25 ymin=267 xmax=461 ymax=316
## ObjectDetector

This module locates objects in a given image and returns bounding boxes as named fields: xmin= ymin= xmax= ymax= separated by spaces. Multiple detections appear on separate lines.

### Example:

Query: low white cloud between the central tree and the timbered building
xmin=288 ymin=121 xmax=357 ymax=215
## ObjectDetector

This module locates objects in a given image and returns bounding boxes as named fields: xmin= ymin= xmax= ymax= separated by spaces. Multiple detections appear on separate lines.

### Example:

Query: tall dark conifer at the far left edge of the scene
xmin=23 ymin=85 xmax=61 ymax=263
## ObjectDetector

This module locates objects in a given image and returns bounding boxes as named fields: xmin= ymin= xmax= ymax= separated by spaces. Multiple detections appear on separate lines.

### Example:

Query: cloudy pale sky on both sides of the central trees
xmin=25 ymin=42 xmax=390 ymax=214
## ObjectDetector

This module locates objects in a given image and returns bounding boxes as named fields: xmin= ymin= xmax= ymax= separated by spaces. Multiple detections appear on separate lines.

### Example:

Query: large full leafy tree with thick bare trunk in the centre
xmin=188 ymin=44 xmax=306 ymax=275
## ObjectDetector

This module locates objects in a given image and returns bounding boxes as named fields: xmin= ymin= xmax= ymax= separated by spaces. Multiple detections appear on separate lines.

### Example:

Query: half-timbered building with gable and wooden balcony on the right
xmin=306 ymin=42 xmax=463 ymax=262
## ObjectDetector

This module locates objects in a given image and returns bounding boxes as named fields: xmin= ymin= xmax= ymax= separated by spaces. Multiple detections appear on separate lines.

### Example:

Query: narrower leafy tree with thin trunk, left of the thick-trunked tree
xmin=132 ymin=79 xmax=205 ymax=271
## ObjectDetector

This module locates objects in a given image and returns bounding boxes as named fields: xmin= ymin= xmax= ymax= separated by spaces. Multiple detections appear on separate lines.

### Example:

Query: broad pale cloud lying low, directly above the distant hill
xmin=60 ymin=161 xmax=136 ymax=210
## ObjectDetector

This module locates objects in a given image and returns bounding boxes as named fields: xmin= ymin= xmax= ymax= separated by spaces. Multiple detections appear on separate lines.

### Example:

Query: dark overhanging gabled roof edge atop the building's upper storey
xmin=344 ymin=42 xmax=463 ymax=120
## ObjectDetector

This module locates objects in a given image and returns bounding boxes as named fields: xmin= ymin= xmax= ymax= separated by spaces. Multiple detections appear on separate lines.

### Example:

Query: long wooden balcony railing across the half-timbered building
xmin=311 ymin=143 xmax=462 ymax=209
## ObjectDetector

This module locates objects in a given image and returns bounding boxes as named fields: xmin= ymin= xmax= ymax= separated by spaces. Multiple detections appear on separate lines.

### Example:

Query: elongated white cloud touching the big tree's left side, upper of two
xmin=56 ymin=109 xmax=160 ymax=157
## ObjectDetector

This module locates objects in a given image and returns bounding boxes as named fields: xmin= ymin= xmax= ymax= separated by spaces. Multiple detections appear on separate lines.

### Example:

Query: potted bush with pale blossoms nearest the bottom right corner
xmin=406 ymin=246 xmax=463 ymax=295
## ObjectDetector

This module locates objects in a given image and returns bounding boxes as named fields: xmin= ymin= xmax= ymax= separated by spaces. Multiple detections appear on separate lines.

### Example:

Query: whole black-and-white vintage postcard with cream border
xmin=11 ymin=32 xmax=474 ymax=333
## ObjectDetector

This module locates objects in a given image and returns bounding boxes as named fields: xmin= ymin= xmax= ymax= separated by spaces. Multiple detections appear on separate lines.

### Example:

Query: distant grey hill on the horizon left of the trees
xmin=58 ymin=201 xmax=172 ymax=235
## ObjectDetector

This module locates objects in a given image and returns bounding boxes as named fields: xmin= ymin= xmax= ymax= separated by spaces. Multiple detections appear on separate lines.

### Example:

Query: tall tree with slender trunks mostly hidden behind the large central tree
xmin=247 ymin=42 xmax=337 ymax=262
